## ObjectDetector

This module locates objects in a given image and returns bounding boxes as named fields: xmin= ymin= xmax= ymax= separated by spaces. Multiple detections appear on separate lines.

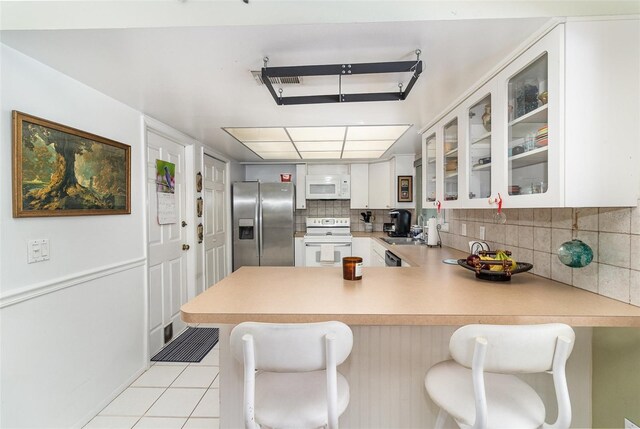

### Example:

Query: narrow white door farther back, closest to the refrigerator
xmin=203 ymin=155 xmax=229 ymax=289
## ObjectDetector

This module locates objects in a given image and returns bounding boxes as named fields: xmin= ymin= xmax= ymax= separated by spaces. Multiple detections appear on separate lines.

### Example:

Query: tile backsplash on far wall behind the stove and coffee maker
xmin=296 ymin=200 xmax=415 ymax=232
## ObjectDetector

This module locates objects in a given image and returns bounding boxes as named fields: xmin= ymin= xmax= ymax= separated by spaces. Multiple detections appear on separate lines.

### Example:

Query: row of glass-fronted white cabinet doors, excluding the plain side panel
xmin=423 ymin=25 xmax=561 ymax=208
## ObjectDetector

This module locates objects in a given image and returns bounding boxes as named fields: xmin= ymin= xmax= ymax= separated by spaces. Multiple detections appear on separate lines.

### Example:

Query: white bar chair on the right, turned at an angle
xmin=425 ymin=323 xmax=575 ymax=429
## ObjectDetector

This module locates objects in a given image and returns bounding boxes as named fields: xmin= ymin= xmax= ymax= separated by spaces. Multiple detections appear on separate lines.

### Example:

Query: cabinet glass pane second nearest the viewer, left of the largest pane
xmin=467 ymin=94 xmax=492 ymax=200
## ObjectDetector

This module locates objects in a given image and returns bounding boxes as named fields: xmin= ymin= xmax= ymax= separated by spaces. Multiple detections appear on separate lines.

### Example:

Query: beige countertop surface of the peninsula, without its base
xmin=182 ymin=233 xmax=640 ymax=327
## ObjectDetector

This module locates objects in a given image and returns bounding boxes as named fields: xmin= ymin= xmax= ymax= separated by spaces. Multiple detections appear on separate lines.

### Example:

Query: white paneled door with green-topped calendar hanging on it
xmin=147 ymin=130 xmax=188 ymax=356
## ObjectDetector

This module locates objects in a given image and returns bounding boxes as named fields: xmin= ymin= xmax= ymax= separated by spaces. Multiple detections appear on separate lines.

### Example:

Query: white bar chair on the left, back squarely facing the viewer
xmin=231 ymin=322 xmax=353 ymax=429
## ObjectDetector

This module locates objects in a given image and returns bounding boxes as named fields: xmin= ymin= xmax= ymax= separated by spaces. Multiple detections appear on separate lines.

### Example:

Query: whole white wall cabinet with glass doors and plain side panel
xmin=422 ymin=19 xmax=640 ymax=208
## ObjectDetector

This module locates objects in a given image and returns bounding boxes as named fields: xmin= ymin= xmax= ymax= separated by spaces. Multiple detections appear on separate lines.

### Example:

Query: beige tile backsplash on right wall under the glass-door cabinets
xmin=442 ymin=207 xmax=640 ymax=306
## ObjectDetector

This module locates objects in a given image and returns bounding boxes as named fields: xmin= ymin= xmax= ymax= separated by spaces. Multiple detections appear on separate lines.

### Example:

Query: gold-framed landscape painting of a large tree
xmin=13 ymin=110 xmax=131 ymax=217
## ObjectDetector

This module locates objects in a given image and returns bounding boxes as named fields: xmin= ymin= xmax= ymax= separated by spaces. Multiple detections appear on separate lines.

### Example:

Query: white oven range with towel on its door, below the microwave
xmin=304 ymin=217 xmax=352 ymax=267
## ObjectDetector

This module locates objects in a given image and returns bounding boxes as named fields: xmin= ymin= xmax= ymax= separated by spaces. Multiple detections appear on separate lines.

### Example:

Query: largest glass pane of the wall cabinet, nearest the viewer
xmin=507 ymin=52 xmax=557 ymax=196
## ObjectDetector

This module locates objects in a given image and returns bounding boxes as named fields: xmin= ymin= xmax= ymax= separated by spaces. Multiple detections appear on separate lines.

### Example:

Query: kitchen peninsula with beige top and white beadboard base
xmin=182 ymin=242 xmax=640 ymax=429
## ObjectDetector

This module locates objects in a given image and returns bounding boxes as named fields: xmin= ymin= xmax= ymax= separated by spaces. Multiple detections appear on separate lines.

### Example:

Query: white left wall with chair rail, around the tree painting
xmin=0 ymin=45 xmax=146 ymax=428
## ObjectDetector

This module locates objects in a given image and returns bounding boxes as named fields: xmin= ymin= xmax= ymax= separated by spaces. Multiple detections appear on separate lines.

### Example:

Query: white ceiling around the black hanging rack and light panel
xmin=0 ymin=0 xmax=636 ymax=161
